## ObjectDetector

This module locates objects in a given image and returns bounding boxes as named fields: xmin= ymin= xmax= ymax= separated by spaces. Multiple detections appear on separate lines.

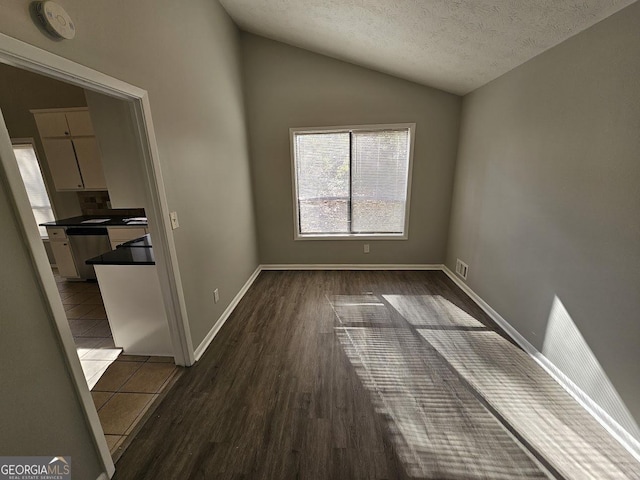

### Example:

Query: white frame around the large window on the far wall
xmin=289 ymin=123 xmax=416 ymax=240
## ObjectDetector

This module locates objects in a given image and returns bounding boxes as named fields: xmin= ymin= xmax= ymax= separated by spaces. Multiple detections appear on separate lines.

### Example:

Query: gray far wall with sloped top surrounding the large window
xmin=242 ymin=33 xmax=461 ymax=264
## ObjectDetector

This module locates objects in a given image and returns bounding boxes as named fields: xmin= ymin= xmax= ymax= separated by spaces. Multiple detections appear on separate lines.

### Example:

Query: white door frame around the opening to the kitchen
xmin=0 ymin=33 xmax=195 ymax=477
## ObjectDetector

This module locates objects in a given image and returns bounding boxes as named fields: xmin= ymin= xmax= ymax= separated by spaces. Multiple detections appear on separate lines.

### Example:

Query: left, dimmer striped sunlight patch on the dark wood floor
xmin=330 ymin=295 xmax=547 ymax=480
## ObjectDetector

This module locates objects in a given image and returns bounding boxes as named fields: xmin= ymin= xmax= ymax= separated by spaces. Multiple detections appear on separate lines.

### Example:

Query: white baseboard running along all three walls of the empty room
xmin=194 ymin=264 xmax=640 ymax=461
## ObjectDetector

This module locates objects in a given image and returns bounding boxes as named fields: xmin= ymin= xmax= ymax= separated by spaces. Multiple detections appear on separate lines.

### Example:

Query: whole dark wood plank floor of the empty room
xmin=115 ymin=271 xmax=640 ymax=480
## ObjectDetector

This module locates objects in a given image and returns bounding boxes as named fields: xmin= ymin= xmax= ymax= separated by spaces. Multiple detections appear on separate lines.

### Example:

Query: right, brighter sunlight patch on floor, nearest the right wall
xmin=418 ymin=329 xmax=640 ymax=480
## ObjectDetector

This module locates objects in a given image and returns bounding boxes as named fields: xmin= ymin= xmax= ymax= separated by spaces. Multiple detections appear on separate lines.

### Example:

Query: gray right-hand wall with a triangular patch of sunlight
xmin=447 ymin=3 xmax=640 ymax=436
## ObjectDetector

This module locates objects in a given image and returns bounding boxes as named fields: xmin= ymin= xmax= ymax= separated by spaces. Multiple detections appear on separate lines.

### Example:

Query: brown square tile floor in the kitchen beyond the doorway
xmin=54 ymin=269 xmax=179 ymax=460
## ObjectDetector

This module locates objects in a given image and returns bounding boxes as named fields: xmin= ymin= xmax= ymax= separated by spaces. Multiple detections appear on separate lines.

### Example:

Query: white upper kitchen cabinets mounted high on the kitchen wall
xmin=31 ymin=107 xmax=107 ymax=190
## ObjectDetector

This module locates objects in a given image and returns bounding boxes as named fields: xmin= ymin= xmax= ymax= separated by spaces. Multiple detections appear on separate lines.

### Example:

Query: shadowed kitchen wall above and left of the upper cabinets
xmin=0 ymin=63 xmax=87 ymax=218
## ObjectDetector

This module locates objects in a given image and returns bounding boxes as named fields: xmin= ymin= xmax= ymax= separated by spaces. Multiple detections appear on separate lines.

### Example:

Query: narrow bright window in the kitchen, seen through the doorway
xmin=13 ymin=140 xmax=55 ymax=238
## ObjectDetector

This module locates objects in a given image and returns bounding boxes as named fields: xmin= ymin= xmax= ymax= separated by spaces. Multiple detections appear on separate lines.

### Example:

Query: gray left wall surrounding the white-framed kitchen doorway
xmin=0 ymin=0 xmax=258 ymax=472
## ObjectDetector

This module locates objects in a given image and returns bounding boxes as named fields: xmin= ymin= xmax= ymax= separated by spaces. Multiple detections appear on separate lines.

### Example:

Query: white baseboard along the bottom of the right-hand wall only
xmin=442 ymin=265 xmax=640 ymax=461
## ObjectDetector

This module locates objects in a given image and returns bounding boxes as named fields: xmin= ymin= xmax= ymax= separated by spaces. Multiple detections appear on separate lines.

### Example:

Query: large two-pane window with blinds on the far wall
xmin=291 ymin=124 xmax=415 ymax=239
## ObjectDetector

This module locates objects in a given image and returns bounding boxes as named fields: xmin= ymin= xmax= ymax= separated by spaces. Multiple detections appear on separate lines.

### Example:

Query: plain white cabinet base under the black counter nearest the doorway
xmin=94 ymin=265 xmax=173 ymax=356
